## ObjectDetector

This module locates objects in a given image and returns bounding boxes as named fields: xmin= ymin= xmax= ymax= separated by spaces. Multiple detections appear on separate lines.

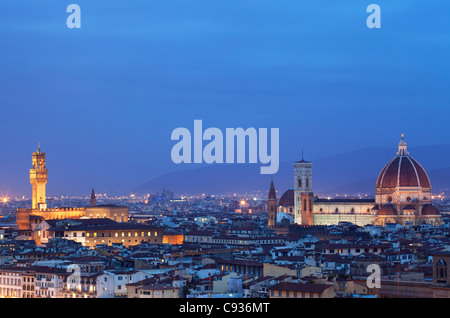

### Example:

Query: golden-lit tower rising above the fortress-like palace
xmin=30 ymin=145 xmax=47 ymax=210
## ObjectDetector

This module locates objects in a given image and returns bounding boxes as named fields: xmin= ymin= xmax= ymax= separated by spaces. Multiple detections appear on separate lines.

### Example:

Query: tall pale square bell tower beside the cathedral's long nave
xmin=294 ymin=151 xmax=313 ymax=225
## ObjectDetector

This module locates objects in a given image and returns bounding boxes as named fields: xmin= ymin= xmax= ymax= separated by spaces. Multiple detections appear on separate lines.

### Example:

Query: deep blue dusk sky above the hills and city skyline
xmin=0 ymin=0 xmax=450 ymax=194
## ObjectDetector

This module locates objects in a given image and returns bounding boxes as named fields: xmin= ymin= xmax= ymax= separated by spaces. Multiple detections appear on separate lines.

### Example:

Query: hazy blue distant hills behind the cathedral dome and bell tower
xmin=132 ymin=145 xmax=450 ymax=195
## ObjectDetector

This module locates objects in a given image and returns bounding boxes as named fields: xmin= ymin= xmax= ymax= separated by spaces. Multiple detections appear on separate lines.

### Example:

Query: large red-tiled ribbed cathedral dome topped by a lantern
xmin=376 ymin=135 xmax=431 ymax=190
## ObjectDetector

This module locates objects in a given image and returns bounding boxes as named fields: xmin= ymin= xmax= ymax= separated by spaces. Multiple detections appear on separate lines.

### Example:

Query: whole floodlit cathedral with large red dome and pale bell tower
xmin=271 ymin=135 xmax=442 ymax=228
